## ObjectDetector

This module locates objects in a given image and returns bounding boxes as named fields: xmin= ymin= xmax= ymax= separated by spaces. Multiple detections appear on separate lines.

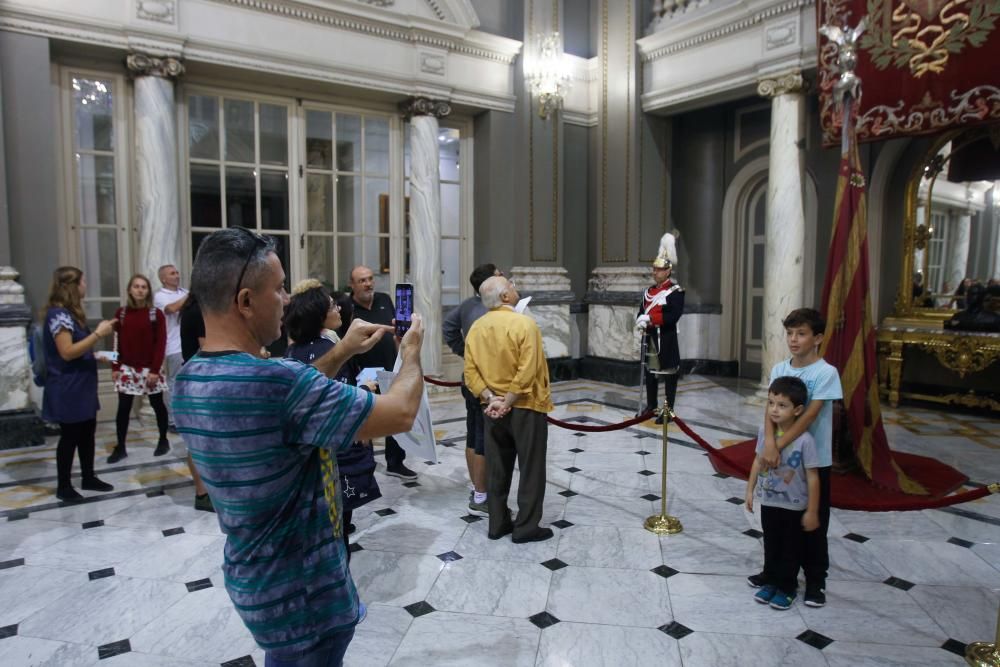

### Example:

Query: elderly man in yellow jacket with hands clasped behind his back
xmin=465 ymin=276 xmax=552 ymax=544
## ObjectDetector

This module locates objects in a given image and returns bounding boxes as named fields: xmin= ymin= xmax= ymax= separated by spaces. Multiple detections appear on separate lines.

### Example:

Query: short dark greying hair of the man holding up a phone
xmin=191 ymin=227 xmax=276 ymax=314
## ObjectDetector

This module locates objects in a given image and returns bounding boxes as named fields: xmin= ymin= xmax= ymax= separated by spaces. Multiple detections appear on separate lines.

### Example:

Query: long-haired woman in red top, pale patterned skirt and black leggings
xmin=108 ymin=274 xmax=170 ymax=463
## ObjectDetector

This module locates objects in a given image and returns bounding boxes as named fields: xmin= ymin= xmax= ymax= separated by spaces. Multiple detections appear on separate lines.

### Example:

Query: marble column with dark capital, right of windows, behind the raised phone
xmin=402 ymin=97 xmax=451 ymax=375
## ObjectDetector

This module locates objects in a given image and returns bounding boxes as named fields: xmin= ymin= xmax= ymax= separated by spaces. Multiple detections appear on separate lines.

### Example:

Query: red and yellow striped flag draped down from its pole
xmin=820 ymin=102 xmax=927 ymax=494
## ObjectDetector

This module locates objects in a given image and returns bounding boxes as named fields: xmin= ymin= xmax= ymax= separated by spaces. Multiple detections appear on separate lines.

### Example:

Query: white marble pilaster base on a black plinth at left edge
xmin=0 ymin=266 xmax=45 ymax=449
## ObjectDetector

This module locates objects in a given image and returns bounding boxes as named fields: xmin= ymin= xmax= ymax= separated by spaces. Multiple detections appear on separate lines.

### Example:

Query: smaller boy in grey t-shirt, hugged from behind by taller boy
xmin=746 ymin=377 xmax=819 ymax=609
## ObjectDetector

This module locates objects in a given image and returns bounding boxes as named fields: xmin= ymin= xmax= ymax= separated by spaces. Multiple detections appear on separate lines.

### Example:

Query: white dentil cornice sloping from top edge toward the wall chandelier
xmin=207 ymin=0 xmax=520 ymax=65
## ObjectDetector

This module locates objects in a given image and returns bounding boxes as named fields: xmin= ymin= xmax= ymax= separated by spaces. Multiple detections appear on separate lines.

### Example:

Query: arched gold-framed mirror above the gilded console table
xmin=896 ymin=125 xmax=1000 ymax=320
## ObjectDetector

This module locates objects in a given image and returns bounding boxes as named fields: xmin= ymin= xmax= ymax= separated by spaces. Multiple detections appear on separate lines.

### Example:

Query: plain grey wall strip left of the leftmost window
xmin=0 ymin=31 xmax=61 ymax=310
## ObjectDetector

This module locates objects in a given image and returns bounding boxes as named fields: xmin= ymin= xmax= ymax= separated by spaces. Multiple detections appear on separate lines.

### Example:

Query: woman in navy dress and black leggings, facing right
xmin=42 ymin=266 xmax=114 ymax=503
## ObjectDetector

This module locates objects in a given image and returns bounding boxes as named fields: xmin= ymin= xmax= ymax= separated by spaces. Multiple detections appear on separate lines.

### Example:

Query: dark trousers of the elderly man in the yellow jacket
xmin=486 ymin=408 xmax=549 ymax=538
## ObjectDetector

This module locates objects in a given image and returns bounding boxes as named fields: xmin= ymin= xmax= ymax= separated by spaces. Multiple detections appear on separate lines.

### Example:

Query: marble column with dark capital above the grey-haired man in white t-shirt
xmin=126 ymin=53 xmax=184 ymax=280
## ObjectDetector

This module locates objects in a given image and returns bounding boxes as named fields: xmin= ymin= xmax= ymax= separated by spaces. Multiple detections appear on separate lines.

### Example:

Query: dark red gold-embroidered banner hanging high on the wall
xmin=817 ymin=0 xmax=1000 ymax=145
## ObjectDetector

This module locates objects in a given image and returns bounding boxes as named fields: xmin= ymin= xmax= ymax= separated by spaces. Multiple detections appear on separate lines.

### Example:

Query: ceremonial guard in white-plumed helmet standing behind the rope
xmin=635 ymin=234 xmax=684 ymax=424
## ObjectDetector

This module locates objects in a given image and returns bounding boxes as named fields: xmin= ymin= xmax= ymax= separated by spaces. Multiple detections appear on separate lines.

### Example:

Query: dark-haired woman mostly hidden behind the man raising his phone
xmin=284 ymin=279 xmax=382 ymax=562
